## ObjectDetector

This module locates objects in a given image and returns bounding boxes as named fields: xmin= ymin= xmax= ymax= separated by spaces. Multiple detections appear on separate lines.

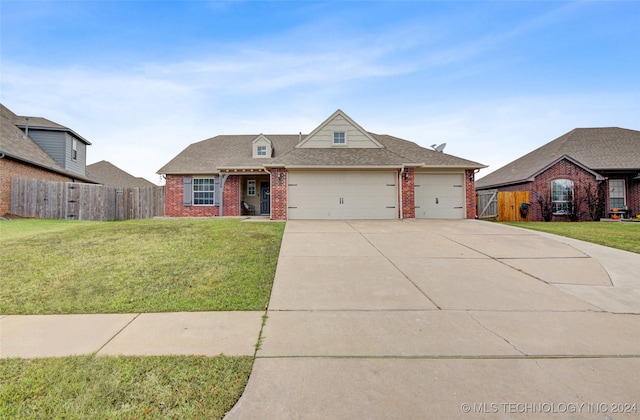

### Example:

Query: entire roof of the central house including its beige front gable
xmin=158 ymin=110 xmax=486 ymax=175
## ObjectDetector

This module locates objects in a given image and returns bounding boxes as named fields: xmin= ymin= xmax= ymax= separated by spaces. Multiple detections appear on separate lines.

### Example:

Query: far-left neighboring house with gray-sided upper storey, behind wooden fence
xmin=0 ymin=104 xmax=94 ymax=215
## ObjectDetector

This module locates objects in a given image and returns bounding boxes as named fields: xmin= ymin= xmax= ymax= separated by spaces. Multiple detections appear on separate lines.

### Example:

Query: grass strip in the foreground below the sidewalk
xmin=0 ymin=356 xmax=253 ymax=419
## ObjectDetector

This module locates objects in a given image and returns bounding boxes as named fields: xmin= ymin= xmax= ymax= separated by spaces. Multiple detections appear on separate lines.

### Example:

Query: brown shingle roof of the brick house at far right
xmin=476 ymin=127 xmax=640 ymax=188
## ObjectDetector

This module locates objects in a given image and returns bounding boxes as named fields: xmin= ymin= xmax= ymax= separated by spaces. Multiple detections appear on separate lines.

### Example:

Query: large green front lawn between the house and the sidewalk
xmin=0 ymin=219 xmax=284 ymax=314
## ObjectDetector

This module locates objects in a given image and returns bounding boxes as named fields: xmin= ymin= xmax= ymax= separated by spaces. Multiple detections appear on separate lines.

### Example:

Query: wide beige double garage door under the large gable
xmin=287 ymin=171 xmax=398 ymax=219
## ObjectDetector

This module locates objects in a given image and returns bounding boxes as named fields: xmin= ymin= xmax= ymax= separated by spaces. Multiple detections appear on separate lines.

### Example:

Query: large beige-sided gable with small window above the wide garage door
xmin=296 ymin=110 xmax=384 ymax=149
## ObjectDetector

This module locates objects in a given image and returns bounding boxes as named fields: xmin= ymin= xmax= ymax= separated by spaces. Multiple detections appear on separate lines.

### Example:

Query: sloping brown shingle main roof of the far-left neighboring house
xmin=0 ymin=104 xmax=92 ymax=182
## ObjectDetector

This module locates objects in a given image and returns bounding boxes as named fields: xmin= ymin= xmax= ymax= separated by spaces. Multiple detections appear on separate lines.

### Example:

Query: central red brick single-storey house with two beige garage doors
xmin=158 ymin=110 xmax=485 ymax=220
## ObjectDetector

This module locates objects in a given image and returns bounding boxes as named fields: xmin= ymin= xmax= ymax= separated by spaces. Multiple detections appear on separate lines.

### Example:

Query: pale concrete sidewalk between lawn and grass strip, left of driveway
xmin=0 ymin=312 xmax=264 ymax=358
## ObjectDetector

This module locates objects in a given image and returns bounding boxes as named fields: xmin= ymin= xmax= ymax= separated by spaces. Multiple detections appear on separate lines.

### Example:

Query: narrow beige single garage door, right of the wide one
xmin=415 ymin=174 xmax=465 ymax=219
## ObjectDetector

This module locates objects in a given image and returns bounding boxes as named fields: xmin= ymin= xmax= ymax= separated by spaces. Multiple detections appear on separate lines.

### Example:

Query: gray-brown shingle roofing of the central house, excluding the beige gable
xmin=158 ymin=133 xmax=485 ymax=174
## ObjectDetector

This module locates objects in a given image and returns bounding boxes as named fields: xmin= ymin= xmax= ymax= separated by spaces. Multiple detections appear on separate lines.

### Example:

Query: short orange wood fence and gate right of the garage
xmin=476 ymin=190 xmax=531 ymax=222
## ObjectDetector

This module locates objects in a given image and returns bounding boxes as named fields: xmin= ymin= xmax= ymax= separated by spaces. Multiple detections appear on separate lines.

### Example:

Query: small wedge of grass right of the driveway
xmin=505 ymin=222 xmax=640 ymax=254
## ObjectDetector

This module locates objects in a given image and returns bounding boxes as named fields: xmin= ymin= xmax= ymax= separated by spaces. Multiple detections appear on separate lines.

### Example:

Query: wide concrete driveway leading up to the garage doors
xmin=227 ymin=220 xmax=640 ymax=419
